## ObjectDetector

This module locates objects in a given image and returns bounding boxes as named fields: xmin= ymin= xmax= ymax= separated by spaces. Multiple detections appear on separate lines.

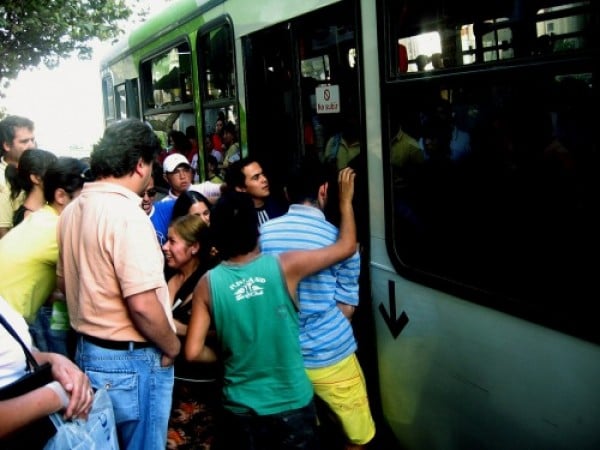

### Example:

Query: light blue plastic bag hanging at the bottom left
xmin=44 ymin=389 xmax=119 ymax=450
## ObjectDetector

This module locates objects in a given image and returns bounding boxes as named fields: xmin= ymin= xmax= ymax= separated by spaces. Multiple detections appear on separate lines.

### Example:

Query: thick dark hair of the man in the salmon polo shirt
xmin=90 ymin=119 xmax=161 ymax=178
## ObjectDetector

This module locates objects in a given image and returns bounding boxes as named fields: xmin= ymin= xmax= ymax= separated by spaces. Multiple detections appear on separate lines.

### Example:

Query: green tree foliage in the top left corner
xmin=0 ymin=0 xmax=147 ymax=96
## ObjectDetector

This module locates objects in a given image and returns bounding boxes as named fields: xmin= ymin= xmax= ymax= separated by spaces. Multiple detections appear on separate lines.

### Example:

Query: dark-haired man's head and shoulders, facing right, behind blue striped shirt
xmin=225 ymin=157 xmax=288 ymax=225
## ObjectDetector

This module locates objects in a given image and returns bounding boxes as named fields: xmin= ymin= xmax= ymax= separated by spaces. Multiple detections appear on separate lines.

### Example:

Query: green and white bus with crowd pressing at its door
xmin=101 ymin=0 xmax=600 ymax=450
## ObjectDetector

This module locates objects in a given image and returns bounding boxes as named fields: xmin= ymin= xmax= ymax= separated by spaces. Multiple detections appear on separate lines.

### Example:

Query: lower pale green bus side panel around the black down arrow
xmin=371 ymin=253 xmax=600 ymax=450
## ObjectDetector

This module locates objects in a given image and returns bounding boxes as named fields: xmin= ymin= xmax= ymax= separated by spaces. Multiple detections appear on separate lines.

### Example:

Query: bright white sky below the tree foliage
xmin=0 ymin=0 xmax=170 ymax=158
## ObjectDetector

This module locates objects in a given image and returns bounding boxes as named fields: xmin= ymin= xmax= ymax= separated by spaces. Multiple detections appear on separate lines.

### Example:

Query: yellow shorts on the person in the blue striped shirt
xmin=306 ymin=353 xmax=375 ymax=445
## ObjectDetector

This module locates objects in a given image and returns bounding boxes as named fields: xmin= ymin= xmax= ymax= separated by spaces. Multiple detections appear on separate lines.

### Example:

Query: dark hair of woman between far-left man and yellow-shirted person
xmin=6 ymin=148 xmax=56 ymax=200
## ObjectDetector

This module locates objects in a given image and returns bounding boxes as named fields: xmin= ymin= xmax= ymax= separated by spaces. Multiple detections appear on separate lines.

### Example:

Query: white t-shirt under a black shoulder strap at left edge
xmin=0 ymin=297 xmax=31 ymax=387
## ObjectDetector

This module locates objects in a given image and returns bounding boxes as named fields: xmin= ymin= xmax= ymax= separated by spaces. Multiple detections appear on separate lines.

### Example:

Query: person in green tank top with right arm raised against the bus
xmin=185 ymin=168 xmax=356 ymax=450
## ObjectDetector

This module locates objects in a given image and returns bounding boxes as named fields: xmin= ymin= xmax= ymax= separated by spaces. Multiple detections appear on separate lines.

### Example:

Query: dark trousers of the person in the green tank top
xmin=224 ymin=400 xmax=319 ymax=450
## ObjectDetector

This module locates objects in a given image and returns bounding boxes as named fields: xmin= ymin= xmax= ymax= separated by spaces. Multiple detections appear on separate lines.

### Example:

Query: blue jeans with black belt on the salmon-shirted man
xmin=75 ymin=337 xmax=174 ymax=450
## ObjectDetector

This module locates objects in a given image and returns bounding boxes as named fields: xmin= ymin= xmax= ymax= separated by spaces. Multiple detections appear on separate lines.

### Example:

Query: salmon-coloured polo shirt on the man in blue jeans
xmin=57 ymin=181 xmax=175 ymax=342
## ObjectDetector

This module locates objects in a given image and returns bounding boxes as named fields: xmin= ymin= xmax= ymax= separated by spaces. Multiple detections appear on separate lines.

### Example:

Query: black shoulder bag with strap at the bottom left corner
xmin=0 ymin=314 xmax=56 ymax=450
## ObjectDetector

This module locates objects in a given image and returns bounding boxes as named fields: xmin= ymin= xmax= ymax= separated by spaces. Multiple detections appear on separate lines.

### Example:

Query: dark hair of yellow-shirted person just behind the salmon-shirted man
xmin=44 ymin=156 xmax=91 ymax=203
